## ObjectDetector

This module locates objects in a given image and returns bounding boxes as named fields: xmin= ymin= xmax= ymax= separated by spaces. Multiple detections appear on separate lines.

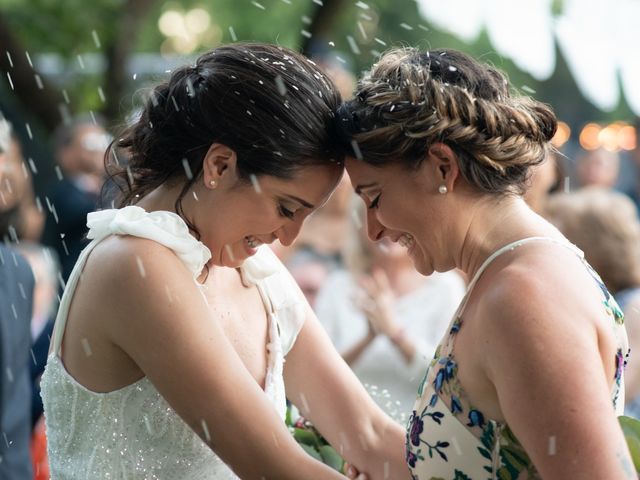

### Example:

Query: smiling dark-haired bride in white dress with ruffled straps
xmin=42 ymin=44 xmax=407 ymax=480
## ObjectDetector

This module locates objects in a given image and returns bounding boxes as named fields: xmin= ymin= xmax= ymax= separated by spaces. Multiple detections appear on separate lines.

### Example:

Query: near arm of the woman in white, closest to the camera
xmin=93 ymin=238 xmax=344 ymax=480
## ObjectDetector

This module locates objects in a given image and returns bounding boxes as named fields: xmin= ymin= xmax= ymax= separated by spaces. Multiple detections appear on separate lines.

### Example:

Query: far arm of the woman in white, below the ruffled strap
xmin=284 ymin=307 xmax=410 ymax=480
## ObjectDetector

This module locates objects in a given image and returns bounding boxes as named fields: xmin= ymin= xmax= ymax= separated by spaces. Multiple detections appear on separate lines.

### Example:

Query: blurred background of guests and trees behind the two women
xmin=0 ymin=0 xmax=640 ymax=479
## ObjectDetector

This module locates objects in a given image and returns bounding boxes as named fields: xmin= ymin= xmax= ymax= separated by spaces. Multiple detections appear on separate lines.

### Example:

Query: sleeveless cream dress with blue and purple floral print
xmin=405 ymin=237 xmax=629 ymax=480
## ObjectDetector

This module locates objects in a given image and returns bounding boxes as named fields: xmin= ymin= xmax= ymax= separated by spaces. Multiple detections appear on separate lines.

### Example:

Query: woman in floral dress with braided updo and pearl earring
xmin=340 ymin=49 xmax=636 ymax=480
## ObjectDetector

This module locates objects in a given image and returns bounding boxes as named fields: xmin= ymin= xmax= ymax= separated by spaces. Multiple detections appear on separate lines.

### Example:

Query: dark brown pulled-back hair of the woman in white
xmin=105 ymin=43 xmax=344 ymax=234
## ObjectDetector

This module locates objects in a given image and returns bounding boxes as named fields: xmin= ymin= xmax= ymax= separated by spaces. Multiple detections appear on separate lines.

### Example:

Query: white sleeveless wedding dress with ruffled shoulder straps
xmin=41 ymin=206 xmax=304 ymax=480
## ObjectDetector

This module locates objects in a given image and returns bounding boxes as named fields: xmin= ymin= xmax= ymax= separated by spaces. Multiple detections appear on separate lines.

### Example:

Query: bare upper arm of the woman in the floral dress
xmin=477 ymin=262 xmax=637 ymax=480
